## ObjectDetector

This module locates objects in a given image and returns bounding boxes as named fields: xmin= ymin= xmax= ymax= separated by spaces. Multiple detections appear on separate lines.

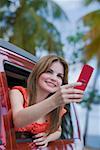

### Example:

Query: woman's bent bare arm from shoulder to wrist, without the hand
xmin=9 ymin=89 xmax=57 ymax=127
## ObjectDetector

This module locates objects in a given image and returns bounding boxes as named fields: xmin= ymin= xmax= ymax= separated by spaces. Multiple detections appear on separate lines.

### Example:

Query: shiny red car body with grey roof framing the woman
xmin=0 ymin=39 xmax=82 ymax=150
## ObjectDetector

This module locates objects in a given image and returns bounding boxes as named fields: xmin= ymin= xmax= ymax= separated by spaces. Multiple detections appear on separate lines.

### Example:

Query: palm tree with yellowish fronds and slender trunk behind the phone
xmin=83 ymin=7 xmax=100 ymax=145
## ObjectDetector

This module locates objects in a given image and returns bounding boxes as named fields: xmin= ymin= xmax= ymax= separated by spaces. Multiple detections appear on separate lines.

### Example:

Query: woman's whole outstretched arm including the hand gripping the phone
xmin=10 ymin=83 xmax=83 ymax=127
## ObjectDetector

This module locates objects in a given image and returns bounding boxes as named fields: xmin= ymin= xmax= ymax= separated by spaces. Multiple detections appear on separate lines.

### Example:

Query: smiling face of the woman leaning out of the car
xmin=38 ymin=61 xmax=64 ymax=94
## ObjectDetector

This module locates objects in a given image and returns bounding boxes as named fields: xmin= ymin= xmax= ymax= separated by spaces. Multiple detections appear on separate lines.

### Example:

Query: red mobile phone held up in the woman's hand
xmin=75 ymin=64 xmax=94 ymax=91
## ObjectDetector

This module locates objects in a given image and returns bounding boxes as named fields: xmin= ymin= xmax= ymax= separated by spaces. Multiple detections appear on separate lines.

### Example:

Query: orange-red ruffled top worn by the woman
xmin=12 ymin=86 xmax=66 ymax=134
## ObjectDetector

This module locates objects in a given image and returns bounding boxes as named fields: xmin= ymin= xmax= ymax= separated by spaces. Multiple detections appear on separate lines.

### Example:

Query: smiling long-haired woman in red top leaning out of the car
xmin=10 ymin=55 xmax=83 ymax=148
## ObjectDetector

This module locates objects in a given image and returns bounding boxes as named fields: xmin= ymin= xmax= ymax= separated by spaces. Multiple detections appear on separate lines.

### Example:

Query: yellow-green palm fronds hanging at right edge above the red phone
xmin=83 ymin=10 xmax=100 ymax=61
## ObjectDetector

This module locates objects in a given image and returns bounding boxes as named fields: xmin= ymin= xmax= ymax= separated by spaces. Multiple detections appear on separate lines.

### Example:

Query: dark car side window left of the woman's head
xmin=4 ymin=62 xmax=30 ymax=88
